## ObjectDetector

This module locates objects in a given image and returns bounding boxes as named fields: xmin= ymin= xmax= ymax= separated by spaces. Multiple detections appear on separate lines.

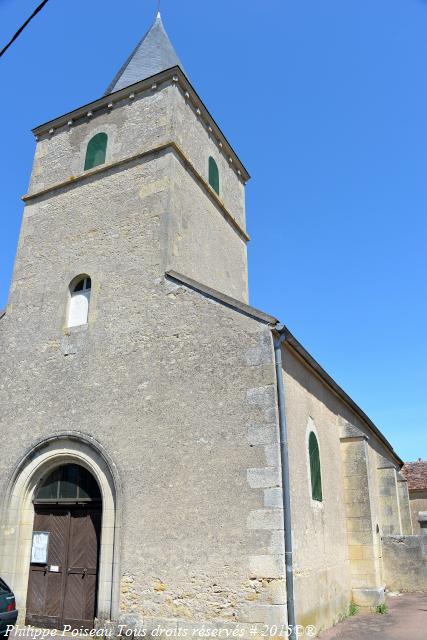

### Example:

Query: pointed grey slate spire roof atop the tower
xmin=105 ymin=11 xmax=185 ymax=95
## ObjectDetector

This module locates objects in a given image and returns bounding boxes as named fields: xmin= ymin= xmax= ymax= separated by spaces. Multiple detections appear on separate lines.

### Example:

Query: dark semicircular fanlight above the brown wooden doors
xmin=34 ymin=464 xmax=101 ymax=503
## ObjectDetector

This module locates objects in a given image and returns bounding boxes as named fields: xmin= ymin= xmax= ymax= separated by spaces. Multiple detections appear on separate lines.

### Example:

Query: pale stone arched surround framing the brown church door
xmin=0 ymin=432 xmax=121 ymax=626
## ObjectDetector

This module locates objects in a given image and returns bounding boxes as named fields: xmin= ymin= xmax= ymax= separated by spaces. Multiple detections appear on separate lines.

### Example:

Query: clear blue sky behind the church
xmin=0 ymin=0 xmax=427 ymax=460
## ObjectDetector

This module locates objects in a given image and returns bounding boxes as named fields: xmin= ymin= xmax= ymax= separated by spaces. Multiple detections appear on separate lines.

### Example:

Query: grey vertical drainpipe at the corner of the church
xmin=273 ymin=323 xmax=297 ymax=640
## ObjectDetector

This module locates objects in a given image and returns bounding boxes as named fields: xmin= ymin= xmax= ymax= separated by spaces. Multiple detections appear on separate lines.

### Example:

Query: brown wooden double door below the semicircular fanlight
xmin=26 ymin=503 xmax=101 ymax=629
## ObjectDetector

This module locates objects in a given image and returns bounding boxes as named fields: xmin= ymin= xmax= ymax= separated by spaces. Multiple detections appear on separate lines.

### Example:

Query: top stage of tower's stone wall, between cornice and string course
xmin=29 ymin=81 xmax=245 ymax=228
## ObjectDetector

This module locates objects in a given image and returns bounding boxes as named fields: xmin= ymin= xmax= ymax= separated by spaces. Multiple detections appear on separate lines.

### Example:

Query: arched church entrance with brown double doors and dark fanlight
xmin=25 ymin=463 xmax=102 ymax=629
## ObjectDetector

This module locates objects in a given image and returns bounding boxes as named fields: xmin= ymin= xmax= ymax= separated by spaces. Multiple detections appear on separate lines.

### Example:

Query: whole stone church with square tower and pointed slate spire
xmin=0 ymin=14 xmax=422 ymax=637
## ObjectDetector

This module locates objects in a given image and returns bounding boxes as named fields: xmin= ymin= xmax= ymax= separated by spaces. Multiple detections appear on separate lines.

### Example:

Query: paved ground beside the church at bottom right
xmin=318 ymin=593 xmax=427 ymax=640
